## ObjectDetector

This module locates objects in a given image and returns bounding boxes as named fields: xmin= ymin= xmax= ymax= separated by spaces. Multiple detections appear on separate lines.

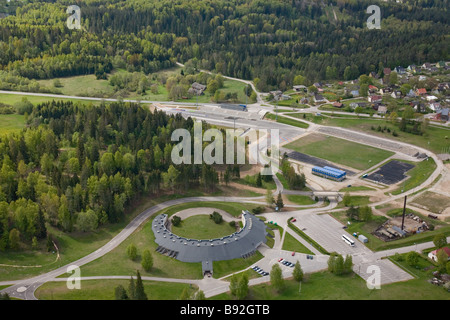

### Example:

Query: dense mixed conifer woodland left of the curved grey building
xmin=0 ymin=101 xmax=239 ymax=250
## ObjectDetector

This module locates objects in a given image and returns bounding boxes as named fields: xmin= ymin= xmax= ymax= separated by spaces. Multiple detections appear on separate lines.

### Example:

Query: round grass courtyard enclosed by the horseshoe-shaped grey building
xmin=172 ymin=215 xmax=236 ymax=240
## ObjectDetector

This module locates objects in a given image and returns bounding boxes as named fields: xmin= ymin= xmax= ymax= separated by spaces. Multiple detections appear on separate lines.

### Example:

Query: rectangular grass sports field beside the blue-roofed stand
xmin=285 ymin=134 xmax=394 ymax=170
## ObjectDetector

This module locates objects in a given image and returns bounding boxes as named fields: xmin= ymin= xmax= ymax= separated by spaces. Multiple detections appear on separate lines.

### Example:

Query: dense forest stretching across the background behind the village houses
xmin=0 ymin=0 xmax=450 ymax=91
